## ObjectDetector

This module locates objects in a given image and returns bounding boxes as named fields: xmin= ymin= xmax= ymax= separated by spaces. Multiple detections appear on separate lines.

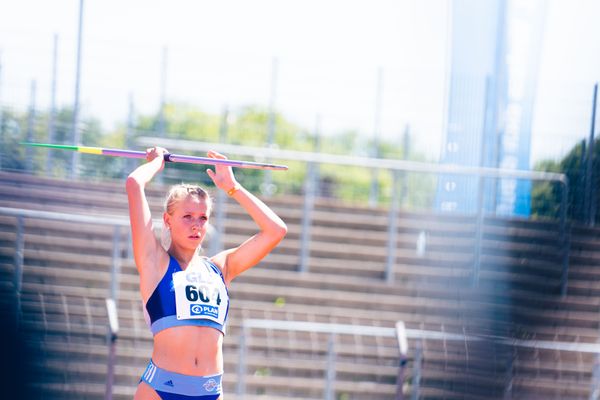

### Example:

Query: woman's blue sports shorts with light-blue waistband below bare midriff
xmin=140 ymin=360 xmax=223 ymax=400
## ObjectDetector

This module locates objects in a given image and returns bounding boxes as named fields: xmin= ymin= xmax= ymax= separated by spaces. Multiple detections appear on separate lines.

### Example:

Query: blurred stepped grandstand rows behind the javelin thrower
xmin=0 ymin=172 xmax=600 ymax=400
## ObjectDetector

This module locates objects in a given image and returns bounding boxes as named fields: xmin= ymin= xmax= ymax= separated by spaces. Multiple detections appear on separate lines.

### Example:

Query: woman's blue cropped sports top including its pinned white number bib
xmin=144 ymin=255 xmax=229 ymax=335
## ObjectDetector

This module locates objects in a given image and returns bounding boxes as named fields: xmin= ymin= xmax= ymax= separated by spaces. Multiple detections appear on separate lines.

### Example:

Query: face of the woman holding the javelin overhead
xmin=165 ymin=196 xmax=209 ymax=249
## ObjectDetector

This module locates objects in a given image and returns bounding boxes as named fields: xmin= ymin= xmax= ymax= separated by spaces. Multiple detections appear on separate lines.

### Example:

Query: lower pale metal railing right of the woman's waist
xmin=237 ymin=319 xmax=600 ymax=400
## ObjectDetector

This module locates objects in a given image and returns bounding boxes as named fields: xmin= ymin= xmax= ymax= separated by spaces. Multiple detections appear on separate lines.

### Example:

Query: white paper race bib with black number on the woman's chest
xmin=173 ymin=265 xmax=227 ymax=324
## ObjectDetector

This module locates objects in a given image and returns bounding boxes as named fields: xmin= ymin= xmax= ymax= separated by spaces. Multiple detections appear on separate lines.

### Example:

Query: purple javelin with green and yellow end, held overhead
xmin=21 ymin=142 xmax=288 ymax=171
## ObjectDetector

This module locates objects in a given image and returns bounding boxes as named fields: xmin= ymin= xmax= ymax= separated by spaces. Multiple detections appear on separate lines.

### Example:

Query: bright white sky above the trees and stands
xmin=0 ymin=0 xmax=600 ymax=164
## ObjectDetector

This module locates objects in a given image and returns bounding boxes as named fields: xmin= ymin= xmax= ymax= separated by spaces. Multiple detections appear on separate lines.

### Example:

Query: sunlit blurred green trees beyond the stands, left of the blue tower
xmin=0 ymin=104 xmax=435 ymax=208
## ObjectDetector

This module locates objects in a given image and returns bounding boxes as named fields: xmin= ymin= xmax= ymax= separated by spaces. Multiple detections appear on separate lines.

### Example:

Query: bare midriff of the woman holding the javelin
xmin=152 ymin=326 xmax=223 ymax=376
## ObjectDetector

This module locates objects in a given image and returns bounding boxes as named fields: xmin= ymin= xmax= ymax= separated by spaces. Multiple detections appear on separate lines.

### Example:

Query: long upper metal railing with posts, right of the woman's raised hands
xmin=139 ymin=137 xmax=570 ymax=295
